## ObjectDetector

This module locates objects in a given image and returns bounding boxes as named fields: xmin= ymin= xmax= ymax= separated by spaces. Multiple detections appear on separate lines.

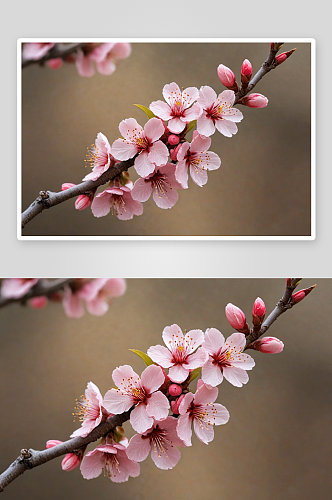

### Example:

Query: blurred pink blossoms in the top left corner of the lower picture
xmin=0 ymin=278 xmax=126 ymax=318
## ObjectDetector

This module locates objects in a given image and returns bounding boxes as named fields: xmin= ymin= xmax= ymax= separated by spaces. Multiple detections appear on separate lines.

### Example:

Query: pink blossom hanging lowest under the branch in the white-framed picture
xmin=91 ymin=181 xmax=143 ymax=220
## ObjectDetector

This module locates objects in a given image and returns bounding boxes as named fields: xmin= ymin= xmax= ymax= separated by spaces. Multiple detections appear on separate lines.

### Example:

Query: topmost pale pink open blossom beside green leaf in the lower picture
xmin=147 ymin=324 xmax=208 ymax=383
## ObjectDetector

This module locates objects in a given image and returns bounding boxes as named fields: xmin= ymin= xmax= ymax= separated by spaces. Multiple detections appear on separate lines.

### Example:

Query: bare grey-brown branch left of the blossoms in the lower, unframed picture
xmin=0 ymin=409 xmax=131 ymax=493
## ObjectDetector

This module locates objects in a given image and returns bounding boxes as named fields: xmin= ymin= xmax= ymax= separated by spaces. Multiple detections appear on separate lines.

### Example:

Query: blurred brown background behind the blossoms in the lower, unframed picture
xmin=0 ymin=279 xmax=332 ymax=500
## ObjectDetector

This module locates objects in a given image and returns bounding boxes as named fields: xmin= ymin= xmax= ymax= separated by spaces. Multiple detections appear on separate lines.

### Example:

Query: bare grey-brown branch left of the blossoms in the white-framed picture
xmin=22 ymin=156 xmax=136 ymax=229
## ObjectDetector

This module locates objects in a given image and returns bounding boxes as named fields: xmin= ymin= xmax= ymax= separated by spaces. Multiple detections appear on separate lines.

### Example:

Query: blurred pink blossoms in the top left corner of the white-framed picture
xmin=22 ymin=42 xmax=131 ymax=77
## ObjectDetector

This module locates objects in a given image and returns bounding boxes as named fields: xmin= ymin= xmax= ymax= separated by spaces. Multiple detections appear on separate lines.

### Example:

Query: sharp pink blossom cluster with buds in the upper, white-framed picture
xmin=62 ymin=54 xmax=267 ymax=220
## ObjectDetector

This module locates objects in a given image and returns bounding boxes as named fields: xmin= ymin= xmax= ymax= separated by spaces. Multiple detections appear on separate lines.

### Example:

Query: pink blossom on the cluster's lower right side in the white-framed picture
xmin=175 ymin=130 xmax=221 ymax=189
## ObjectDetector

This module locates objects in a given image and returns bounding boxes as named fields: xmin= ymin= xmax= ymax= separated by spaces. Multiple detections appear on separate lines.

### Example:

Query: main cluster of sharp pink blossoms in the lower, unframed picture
xmin=47 ymin=299 xmax=282 ymax=482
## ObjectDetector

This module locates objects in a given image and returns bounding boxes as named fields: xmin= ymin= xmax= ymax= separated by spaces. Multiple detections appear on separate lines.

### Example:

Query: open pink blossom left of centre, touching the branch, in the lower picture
xmin=104 ymin=365 xmax=169 ymax=433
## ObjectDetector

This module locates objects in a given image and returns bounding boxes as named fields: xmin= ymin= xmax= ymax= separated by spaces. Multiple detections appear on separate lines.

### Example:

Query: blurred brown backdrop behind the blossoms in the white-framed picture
xmin=22 ymin=42 xmax=311 ymax=236
